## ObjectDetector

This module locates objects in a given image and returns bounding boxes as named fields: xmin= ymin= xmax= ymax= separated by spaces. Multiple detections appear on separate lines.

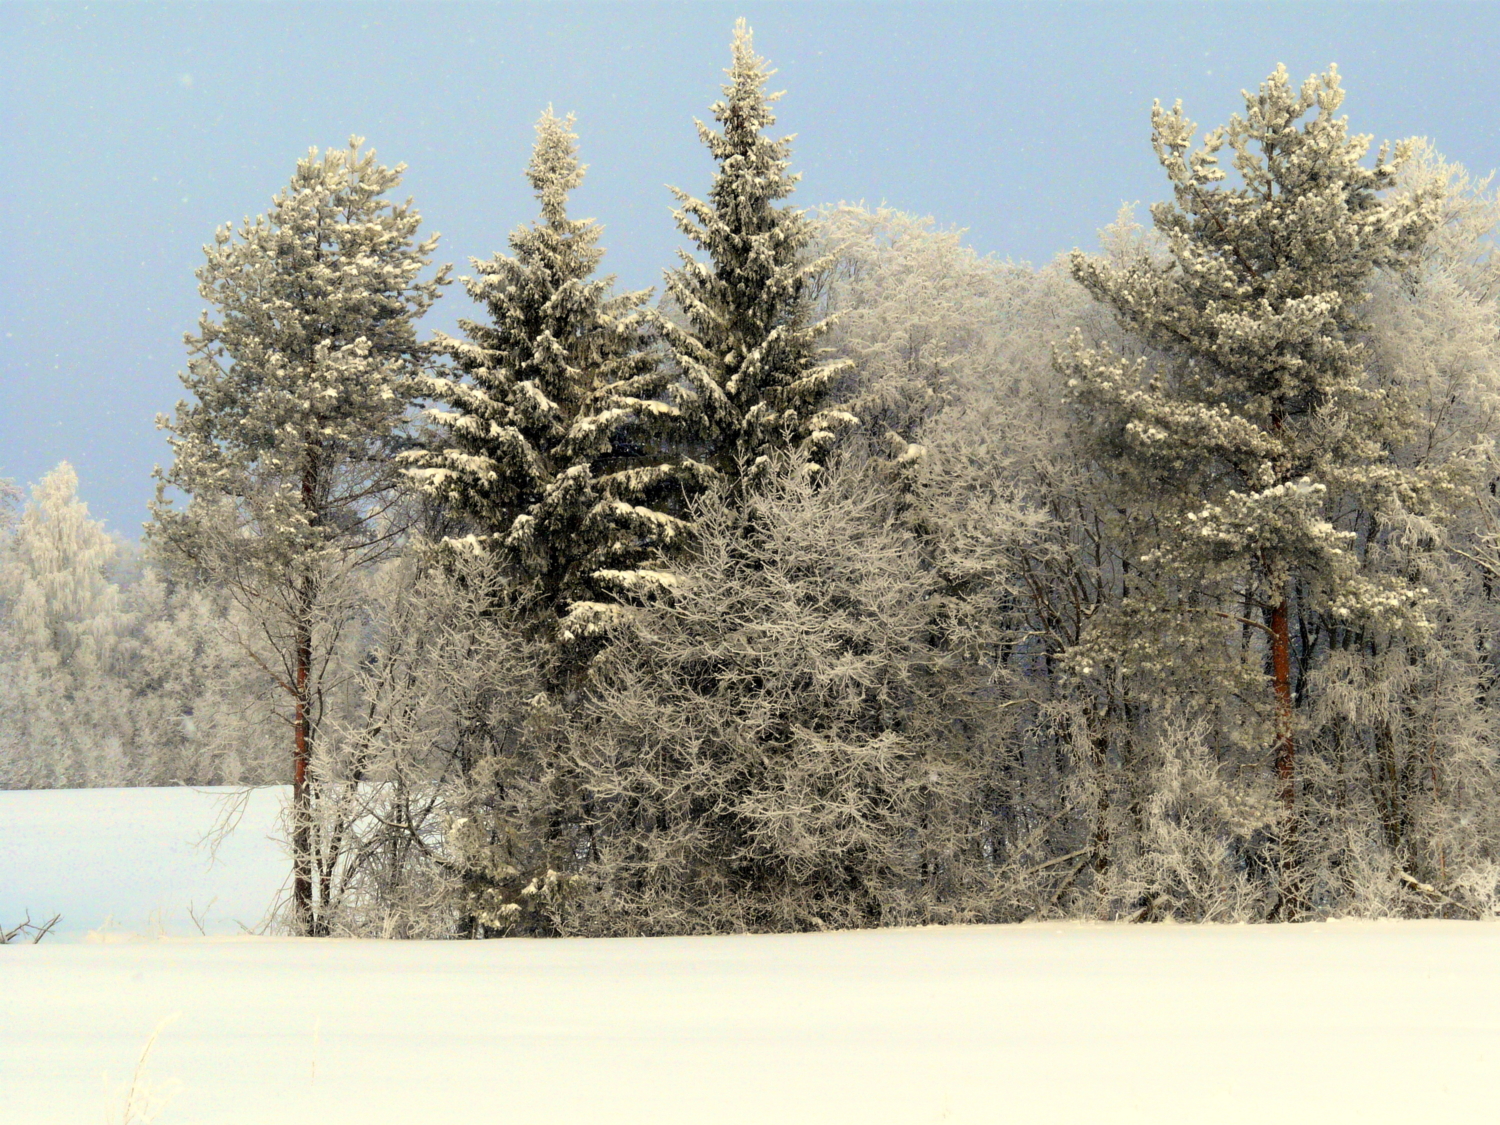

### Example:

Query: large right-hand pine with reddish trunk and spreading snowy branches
xmin=1059 ymin=68 xmax=1437 ymax=917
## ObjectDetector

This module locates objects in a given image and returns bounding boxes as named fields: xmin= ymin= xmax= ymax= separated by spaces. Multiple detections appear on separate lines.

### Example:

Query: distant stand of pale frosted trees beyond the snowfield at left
xmin=0 ymin=462 xmax=282 ymax=788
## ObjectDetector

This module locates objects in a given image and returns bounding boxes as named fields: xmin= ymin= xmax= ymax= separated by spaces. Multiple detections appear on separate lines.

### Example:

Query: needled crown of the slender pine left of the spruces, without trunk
xmin=150 ymin=137 xmax=447 ymax=573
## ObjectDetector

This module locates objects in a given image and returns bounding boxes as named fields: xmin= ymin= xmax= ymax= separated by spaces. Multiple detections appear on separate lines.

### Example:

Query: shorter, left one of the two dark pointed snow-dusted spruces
xmin=404 ymin=110 xmax=681 ymax=675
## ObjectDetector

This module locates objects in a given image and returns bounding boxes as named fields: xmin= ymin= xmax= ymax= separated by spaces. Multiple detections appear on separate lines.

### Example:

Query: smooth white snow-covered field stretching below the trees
xmin=0 ymin=791 xmax=1500 ymax=1125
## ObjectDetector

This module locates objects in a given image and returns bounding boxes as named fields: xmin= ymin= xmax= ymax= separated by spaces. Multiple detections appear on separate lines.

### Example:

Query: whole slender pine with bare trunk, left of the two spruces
xmin=149 ymin=138 xmax=446 ymax=933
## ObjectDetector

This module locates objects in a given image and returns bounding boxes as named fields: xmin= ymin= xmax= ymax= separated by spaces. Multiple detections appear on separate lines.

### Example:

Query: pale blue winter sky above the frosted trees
xmin=0 ymin=0 xmax=1500 ymax=539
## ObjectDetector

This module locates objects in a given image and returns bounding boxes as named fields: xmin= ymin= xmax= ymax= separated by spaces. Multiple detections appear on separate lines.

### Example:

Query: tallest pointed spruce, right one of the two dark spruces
xmin=656 ymin=20 xmax=855 ymax=495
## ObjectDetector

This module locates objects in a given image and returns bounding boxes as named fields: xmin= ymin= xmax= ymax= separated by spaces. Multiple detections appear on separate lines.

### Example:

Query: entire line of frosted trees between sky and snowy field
xmin=0 ymin=23 xmax=1500 ymax=936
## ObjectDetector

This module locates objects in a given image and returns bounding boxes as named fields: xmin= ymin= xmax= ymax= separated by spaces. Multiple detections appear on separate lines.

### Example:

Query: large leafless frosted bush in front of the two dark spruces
xmin=552 ymin=461 xmax=993 ymax=935
